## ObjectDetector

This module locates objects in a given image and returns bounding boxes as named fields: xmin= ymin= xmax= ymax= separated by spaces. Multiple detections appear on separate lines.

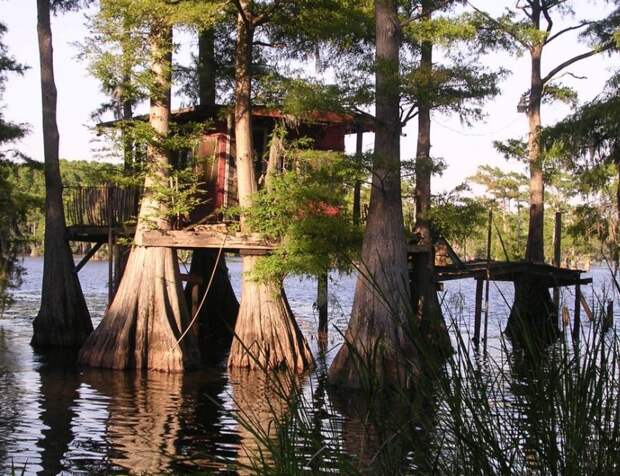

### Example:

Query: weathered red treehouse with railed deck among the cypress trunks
xmin=64 ymin=106 xmax=373 ymax=281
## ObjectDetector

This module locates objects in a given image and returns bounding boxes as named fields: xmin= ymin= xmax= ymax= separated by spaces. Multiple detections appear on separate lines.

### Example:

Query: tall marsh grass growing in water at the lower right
xmin=229 ymin=268 xmax=620 ymax=475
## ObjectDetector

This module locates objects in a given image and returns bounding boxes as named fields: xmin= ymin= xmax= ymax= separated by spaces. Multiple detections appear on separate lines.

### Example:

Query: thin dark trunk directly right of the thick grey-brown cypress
xmin=411 ymin=6 xmax=450 ymax=352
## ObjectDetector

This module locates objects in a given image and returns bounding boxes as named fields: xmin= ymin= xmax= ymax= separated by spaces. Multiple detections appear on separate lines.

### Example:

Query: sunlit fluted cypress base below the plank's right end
xmin=228 ymin=256 xmax=314 ymax=372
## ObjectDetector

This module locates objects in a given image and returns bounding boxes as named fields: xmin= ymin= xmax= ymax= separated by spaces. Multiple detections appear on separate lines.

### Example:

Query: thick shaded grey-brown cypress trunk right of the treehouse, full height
xmin=329 ymin=0 xmax=416 ymax=388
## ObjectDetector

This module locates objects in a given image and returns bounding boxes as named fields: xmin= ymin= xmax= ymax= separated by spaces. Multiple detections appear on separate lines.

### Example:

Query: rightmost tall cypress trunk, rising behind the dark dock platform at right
xmin=506 ymin=41 xmax=560 ymax=346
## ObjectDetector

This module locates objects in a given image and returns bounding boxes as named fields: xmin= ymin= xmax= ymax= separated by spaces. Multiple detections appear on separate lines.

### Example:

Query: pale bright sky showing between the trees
xmin=0 ymin=0 xmax=620 ymax=192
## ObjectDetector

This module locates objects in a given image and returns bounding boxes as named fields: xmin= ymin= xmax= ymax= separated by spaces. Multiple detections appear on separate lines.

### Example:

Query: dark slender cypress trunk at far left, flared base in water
xmin=32 ymin=0 xmax=93 ymax=347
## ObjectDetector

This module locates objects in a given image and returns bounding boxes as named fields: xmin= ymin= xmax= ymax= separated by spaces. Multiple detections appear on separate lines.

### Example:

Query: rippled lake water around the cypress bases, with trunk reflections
xmin=0 ymin=258 xmax=619 ymax=474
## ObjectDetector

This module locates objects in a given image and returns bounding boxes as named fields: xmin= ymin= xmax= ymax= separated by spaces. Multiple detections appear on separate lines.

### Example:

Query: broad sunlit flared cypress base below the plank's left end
xmin=78 ymin=246 xmax=200 ymax=372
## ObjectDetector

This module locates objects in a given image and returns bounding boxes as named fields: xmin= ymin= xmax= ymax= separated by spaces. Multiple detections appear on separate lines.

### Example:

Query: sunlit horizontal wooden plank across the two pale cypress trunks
xmin=142 ymin=230 xmax=277 ymax=251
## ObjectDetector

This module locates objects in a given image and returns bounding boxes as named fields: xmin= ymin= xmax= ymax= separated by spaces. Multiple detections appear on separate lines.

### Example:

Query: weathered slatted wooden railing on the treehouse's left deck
xmin=63 ymin=186 xmax=140 ymax=227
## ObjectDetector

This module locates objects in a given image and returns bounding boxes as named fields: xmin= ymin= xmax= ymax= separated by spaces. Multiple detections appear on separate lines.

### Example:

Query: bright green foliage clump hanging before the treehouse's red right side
xmin=237 ymin=150 xmax=361 ymax=280
